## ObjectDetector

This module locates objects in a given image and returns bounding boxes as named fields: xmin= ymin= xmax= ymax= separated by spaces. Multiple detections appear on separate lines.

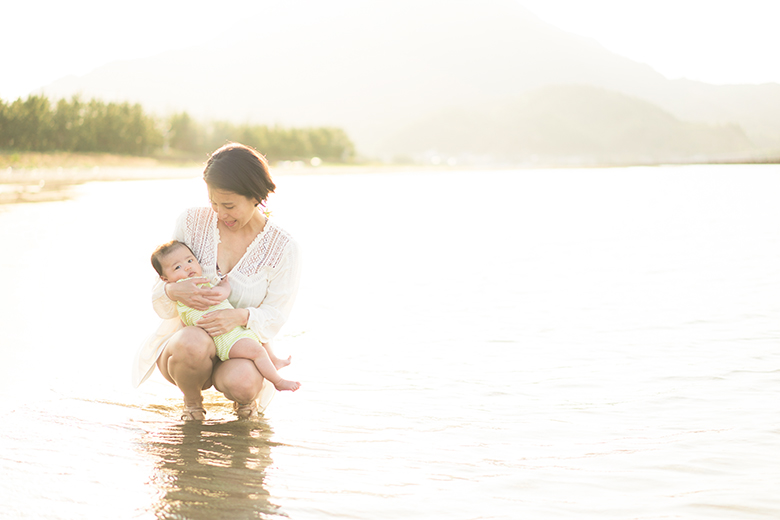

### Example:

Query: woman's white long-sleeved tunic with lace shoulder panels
xmin=132 ymin=208 xmax=301 ymax=387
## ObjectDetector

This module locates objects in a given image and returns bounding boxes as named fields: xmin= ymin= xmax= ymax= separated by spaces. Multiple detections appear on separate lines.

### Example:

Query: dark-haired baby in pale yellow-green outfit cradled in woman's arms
xmin=152 ymin=240 xmax=301 ymax=392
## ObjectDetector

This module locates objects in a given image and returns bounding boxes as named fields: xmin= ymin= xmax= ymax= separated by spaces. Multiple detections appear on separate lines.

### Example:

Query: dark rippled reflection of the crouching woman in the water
xmin=140 ymin=418 xmax=286 ymax=520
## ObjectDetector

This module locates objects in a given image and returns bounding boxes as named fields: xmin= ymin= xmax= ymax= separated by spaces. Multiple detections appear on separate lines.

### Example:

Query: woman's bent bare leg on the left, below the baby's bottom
xmin=157 ymin=327 xmax=217 ymax=416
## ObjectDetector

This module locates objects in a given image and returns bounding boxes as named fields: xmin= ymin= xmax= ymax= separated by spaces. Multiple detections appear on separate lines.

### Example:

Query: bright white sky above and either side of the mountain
xmin=0 ymin=0 xmax=780 ymax=100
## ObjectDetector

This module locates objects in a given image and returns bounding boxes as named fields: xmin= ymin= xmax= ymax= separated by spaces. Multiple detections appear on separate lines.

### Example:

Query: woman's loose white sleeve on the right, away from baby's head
xmin=247 ymin=240 xmax=301 ymax=343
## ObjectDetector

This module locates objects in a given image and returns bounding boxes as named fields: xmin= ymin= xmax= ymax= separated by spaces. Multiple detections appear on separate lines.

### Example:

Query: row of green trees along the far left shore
xmin=0 ymin=95 xmax=355 ymax=162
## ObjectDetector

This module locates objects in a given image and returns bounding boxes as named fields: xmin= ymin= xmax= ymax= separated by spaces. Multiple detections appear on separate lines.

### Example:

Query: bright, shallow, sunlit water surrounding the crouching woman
xmin=0 ymin=166 xmax=780 ymax=520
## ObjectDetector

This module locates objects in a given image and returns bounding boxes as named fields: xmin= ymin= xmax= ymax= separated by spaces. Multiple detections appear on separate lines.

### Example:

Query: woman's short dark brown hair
xmin=203 ymin=143 xmax=276 ymax=203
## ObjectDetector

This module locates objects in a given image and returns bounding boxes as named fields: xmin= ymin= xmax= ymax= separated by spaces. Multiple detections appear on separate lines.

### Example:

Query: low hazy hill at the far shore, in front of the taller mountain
xmin=381 ymin=85 xmax=754 ymax=164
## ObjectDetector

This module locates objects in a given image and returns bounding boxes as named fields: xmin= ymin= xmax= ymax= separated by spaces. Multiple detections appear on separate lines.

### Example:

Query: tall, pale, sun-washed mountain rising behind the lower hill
xmin=42 ymin=0 xmax=780 ymax=162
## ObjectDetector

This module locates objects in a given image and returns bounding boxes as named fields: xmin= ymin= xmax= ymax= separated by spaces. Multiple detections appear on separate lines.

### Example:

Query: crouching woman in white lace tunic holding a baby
xmin=133 ymin=143 xmax=300 ymax=420
